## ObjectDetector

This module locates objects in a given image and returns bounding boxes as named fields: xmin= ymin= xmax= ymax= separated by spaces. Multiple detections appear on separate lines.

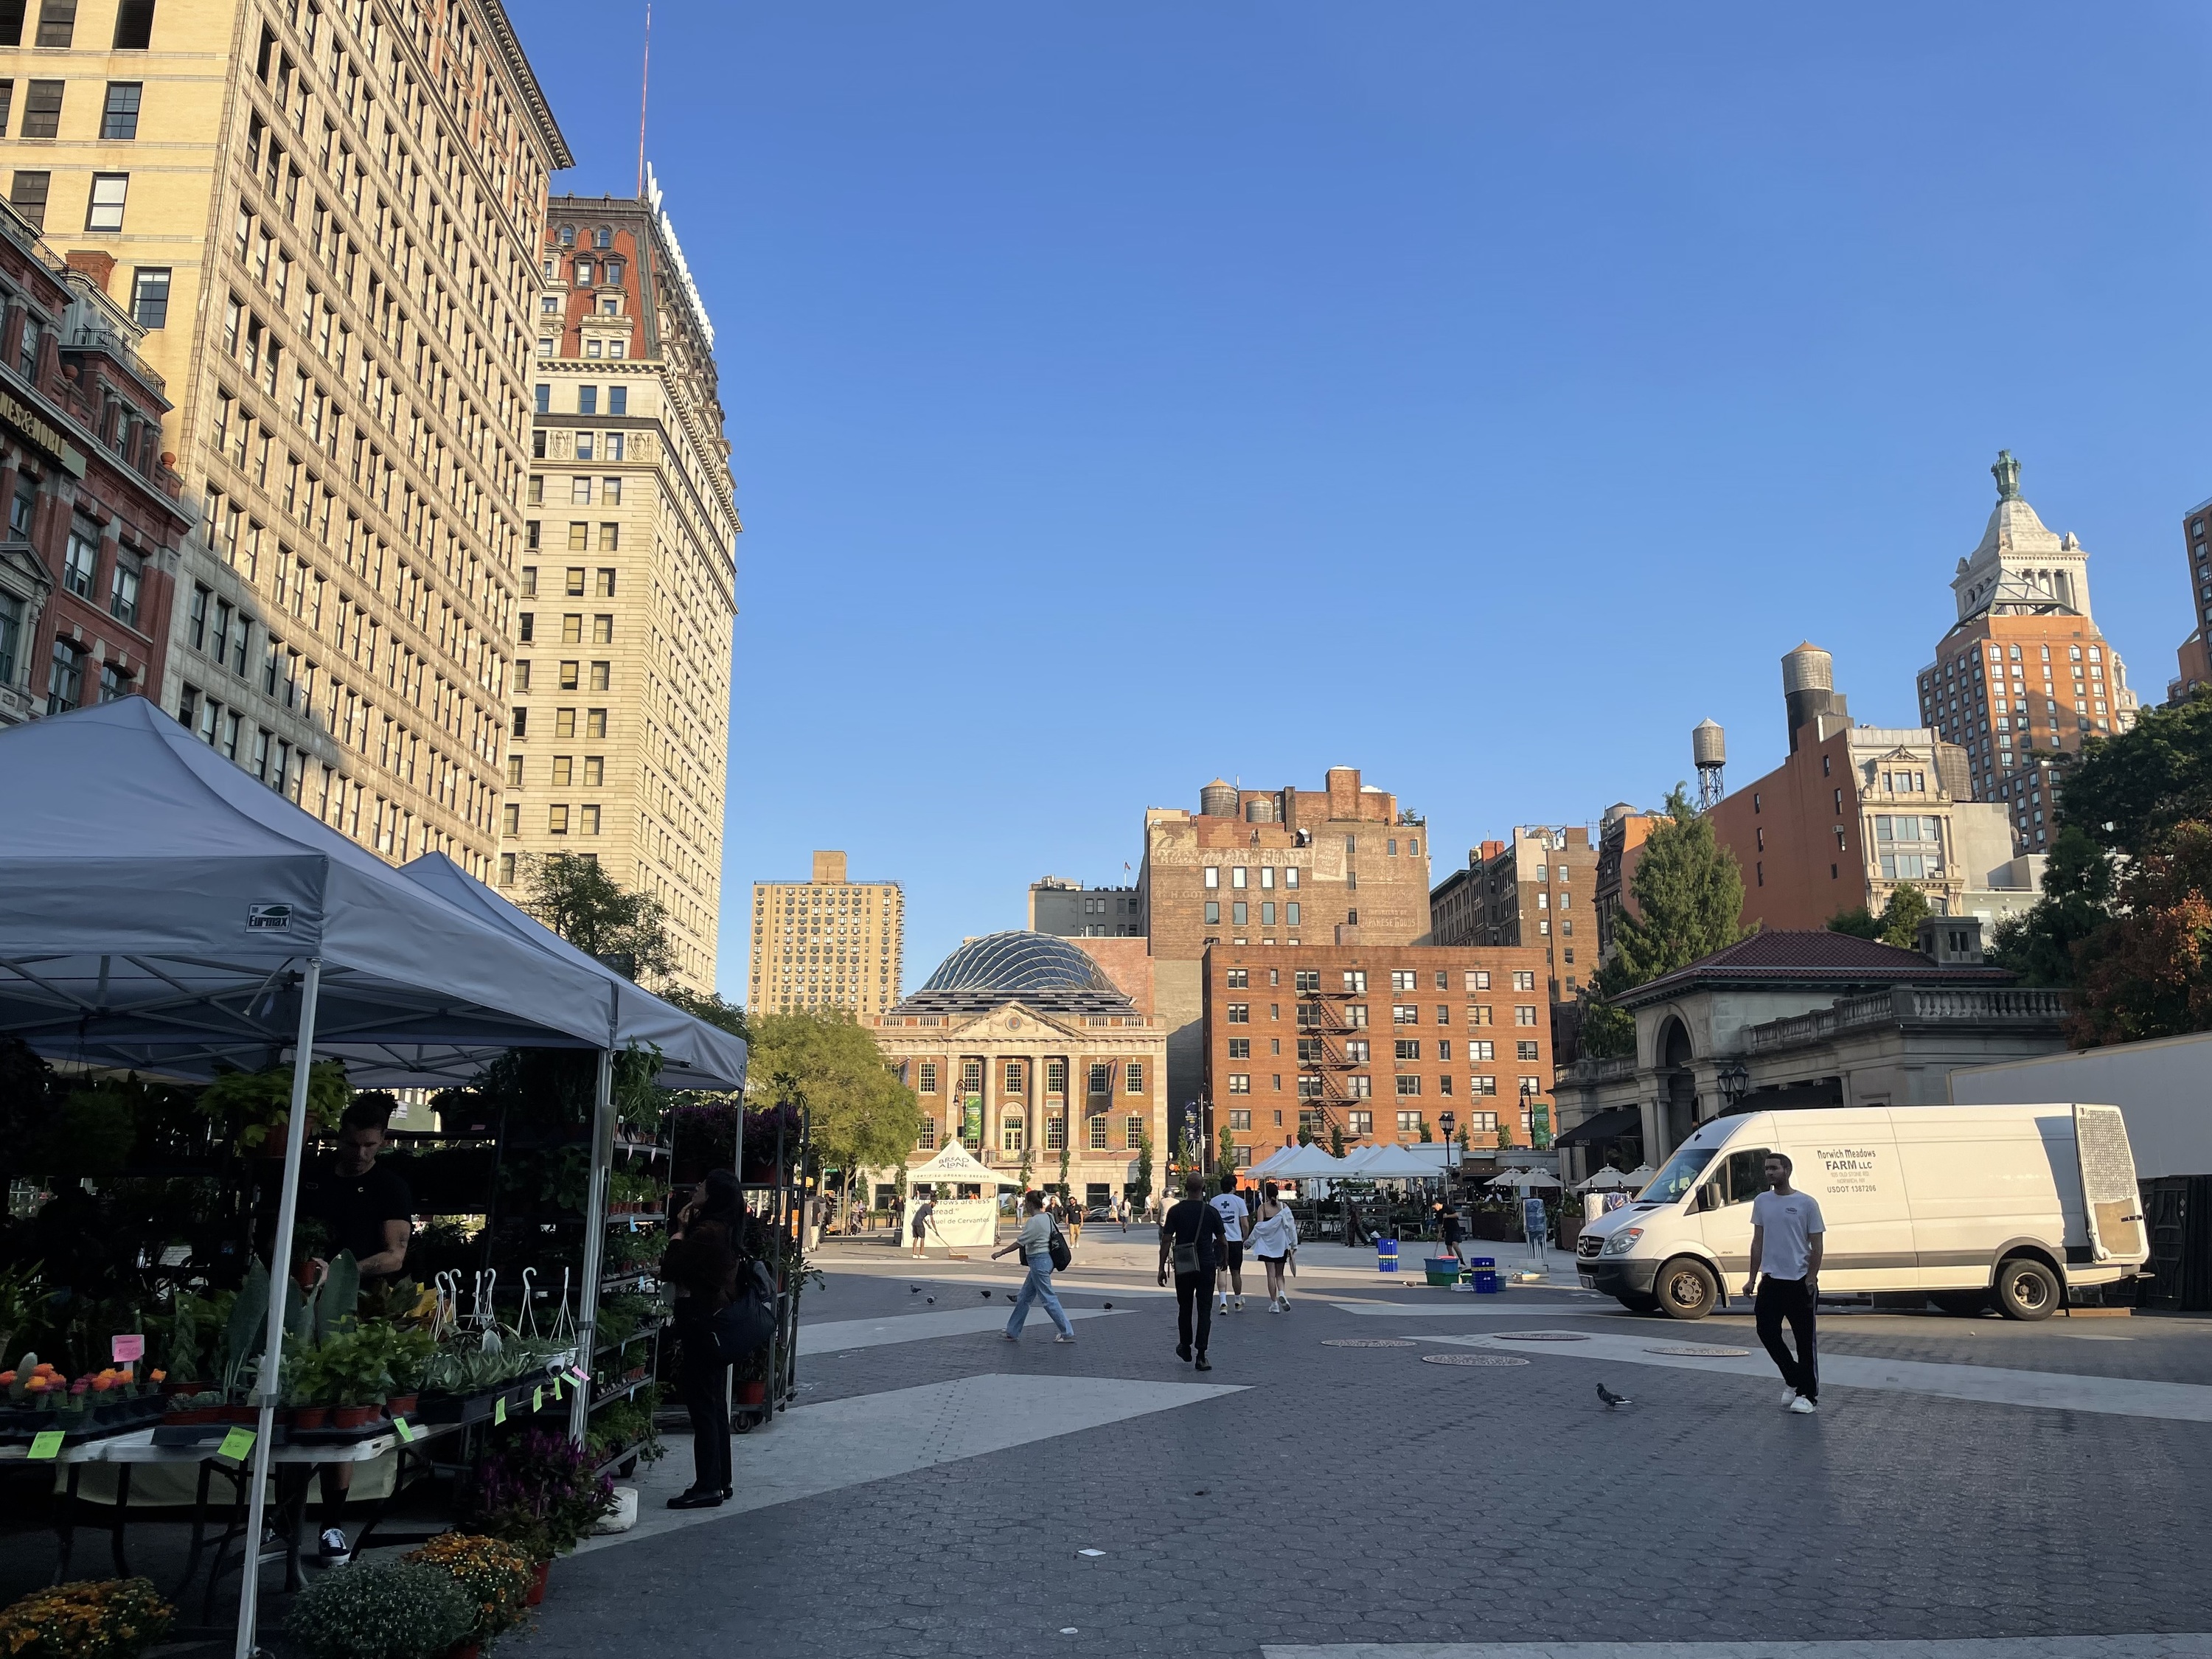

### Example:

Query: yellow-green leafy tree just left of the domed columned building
xmin=745 ymin=1009 xmax=922 ymax=1203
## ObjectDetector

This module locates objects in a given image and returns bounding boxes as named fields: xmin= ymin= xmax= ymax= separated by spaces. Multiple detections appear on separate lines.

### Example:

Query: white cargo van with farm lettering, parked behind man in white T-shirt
xmin=1575 ymin=1106 xmax=2150 ymax=1318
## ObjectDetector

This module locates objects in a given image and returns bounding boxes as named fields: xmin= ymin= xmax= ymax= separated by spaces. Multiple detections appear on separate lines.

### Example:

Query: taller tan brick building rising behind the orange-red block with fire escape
xmin=1137 ymin=765 xmax=1429 ymax=1141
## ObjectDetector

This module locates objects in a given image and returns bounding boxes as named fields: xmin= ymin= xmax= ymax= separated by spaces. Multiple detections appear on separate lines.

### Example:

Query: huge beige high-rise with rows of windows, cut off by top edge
xmin=0 ymin=0 xmax=571 ymax=878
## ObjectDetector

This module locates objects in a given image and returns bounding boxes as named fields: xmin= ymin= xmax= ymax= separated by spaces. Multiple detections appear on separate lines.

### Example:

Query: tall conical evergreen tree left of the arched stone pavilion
xmin=1582 ymin=783 xmax=1752 ymax=1057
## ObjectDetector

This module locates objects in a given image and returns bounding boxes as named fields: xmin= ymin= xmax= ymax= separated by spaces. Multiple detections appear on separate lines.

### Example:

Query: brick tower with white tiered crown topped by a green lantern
xmin=1920 ymin=451 xmax=2137 ymax=854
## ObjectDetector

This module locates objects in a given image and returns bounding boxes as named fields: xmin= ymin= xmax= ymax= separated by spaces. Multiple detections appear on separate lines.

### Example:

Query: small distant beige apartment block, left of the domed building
xmin=745 ymin=852 xmax=907 ymax=1022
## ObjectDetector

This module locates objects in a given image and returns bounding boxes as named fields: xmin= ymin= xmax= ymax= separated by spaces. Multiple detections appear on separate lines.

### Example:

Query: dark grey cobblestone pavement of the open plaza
xmin=513 ymin=1274 xmax=2212 ymax=1659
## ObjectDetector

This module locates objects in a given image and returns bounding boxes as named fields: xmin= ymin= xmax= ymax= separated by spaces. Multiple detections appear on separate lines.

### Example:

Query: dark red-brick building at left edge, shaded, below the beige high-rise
xmin=0 ymin=204 xmax=190 ymax=726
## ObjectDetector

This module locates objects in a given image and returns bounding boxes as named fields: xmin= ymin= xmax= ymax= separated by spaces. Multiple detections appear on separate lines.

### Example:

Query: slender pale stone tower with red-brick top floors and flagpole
xmin=498 ymin=188 xmax=741 ymax=991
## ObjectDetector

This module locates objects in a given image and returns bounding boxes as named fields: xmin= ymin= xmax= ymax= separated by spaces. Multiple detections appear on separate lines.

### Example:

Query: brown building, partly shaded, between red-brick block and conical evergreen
xmin=1429 ymin=823 xmax=1597 ymax=1002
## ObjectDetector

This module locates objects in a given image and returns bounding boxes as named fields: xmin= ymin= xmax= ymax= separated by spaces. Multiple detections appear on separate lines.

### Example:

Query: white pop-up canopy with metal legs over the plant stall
xmin=0 ymin=697 xmax=745 ymax=1659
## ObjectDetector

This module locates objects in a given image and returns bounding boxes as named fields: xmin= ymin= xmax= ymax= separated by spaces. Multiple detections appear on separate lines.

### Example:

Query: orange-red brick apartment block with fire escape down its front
xmin=1203 ymin=945 xmax=1553 ymax=1166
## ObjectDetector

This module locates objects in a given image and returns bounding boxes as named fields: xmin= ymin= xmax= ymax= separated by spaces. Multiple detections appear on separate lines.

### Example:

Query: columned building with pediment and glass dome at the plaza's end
xmin=869 ymin=931 xmax=1168 ymax=1206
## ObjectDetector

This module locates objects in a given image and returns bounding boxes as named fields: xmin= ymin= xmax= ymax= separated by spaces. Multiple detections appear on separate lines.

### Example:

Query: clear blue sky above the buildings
xmin=518 ymin=0 xmax=2212 ymax=995
